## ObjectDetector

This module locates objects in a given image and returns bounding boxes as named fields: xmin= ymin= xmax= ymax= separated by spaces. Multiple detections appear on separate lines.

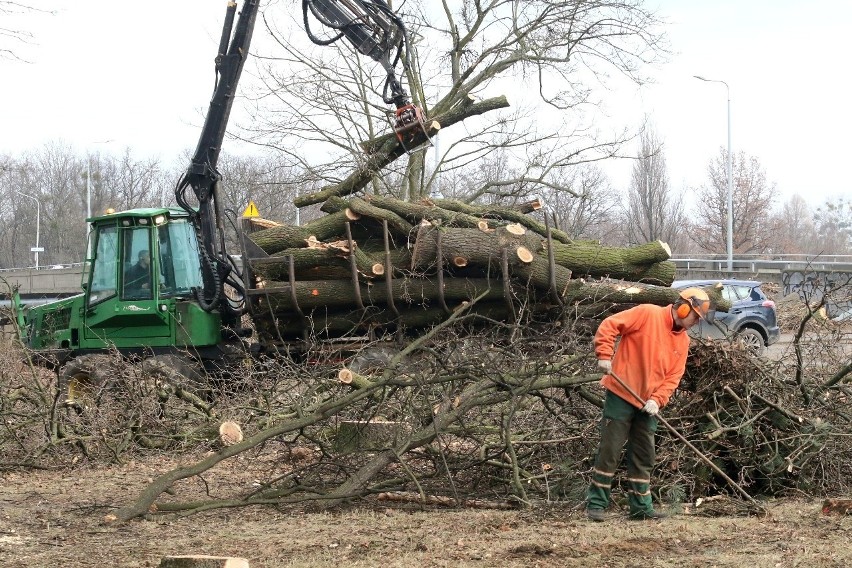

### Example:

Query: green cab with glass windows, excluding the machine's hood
xmin=81 ymin=208 xmax=221 ymax=347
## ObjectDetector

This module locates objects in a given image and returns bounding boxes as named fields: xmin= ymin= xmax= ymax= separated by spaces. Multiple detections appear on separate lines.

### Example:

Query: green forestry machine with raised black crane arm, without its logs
xmin=13 ymin=0 xmax=436 ymax=404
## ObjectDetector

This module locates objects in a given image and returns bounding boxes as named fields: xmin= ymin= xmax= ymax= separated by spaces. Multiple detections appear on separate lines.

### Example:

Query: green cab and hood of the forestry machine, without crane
xmin=21 ymin=208 xmax=222 ymax=364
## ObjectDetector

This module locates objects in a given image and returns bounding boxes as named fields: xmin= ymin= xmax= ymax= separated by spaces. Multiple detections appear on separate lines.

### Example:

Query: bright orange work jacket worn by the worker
xmin=595 ymin=304 xmax=689 ymax=408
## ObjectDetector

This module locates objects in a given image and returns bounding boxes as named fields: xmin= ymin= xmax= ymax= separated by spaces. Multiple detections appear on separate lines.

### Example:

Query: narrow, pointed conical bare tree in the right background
xmin=625 ymin=128 xmax=686 ymax=250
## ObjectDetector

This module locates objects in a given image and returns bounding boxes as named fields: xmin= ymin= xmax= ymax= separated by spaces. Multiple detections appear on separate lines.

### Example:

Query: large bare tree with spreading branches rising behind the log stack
xmin=243 ymin=0 xmax=664 ymax=205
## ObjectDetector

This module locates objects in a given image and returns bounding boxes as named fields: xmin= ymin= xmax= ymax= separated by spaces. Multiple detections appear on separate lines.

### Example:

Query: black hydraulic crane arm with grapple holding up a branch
xmin=175 ymin=0 xmax=428 ymax=319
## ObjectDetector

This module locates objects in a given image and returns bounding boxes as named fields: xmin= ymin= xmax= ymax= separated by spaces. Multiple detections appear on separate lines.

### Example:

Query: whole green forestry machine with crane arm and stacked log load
xmin=13 ymin=0 xmax=676 ymax=403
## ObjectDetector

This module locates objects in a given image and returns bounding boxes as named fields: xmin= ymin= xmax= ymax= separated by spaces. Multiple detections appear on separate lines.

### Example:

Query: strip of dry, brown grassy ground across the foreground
xmin=0 ymin=450 xmax=852 ymax=568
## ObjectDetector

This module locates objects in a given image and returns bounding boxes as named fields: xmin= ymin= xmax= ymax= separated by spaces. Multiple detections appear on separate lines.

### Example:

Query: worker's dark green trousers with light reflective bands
xmin=587 ymin=391 xmax=657 ymax=515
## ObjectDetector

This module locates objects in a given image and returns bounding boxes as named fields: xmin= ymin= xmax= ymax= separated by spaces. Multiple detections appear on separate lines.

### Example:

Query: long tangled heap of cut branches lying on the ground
xmin=0 ymin=296 xmax=852 ymax=519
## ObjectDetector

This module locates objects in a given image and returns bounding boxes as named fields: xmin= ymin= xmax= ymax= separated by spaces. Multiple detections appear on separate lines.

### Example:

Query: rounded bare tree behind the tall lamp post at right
xmin=690 ymin=149 xmax=777 ymax=254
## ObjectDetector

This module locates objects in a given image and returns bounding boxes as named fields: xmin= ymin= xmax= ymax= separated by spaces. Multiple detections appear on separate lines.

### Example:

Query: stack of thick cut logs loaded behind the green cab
xmin=238 ymin=195 xmax=692 ymax=345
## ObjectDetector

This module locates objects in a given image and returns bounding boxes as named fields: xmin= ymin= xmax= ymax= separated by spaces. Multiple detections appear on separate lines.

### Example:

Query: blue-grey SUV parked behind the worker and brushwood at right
xmin=672 ymin=280 xmax=781 ymax=355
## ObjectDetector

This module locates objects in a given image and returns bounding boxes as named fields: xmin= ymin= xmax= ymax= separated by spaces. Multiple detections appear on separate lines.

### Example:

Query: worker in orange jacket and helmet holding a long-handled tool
xmin=586 ymin=288 xmax=710 ymax=521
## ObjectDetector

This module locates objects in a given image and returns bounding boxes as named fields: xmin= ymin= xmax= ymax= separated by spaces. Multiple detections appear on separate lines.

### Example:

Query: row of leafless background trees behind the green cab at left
xmin=0 ymin=148 xmax=296 ymax=268
